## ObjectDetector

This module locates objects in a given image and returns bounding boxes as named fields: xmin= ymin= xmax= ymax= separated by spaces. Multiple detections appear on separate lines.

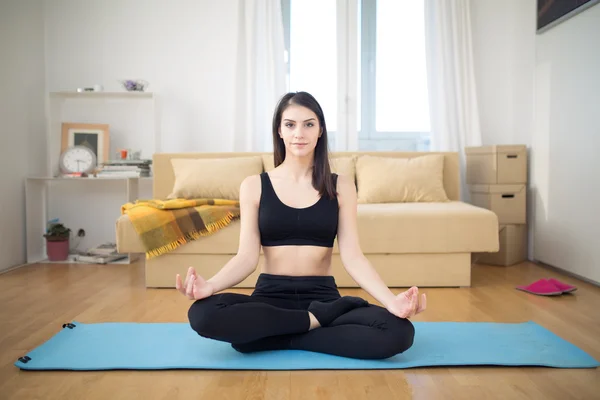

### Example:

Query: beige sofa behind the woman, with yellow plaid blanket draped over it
xmin=116 ymin=152 xmax=499 ymax=288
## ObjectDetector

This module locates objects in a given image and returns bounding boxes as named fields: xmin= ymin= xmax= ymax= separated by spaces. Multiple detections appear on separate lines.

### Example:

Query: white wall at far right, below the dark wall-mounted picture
xmin=532 ymin=5 xmax=600 ymax=282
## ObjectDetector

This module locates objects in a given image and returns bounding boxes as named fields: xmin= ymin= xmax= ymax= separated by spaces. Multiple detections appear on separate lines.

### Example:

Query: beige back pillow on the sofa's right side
xmin=356 ymin=154 xmax=448 ymax=204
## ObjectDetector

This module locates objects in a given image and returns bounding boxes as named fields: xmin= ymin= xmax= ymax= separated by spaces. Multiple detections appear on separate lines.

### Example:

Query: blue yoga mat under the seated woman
xmin=15 ymin=321 xmax=600 ymax=370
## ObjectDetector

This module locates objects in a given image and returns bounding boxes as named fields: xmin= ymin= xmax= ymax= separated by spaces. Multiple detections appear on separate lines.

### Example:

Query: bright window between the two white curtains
xmin=282 ymin=0 xmax=430 ymax=151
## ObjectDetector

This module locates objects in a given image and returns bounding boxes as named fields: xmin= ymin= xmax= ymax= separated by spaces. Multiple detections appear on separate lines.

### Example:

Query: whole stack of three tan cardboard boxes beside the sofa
xmin=465 ymin=145 xmax=527 ymax=266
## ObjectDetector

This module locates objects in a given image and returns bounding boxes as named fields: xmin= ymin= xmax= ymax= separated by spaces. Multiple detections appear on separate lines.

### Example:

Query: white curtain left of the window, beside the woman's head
xmin=233 ymin=0 xmax=286 ymax=151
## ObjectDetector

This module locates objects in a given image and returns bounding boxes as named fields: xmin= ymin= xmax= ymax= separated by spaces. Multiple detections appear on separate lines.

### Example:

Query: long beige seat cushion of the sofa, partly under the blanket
xmin=117 ymin=201 xmax=499 ymax=255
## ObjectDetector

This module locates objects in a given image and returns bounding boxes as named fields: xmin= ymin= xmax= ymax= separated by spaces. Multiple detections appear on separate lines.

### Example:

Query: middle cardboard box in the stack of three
xmin=469 ymin=185 xmax=527 ymax=225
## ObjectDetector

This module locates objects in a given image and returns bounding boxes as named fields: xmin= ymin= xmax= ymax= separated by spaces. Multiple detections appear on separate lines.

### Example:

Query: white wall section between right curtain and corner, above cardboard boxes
xmin=471 ymin=0 xmax=535 ymax=145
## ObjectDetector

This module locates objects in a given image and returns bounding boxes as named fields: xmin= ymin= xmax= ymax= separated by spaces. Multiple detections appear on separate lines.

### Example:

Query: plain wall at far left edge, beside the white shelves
xmin=0 ymin=0 xmax=45 ymax=270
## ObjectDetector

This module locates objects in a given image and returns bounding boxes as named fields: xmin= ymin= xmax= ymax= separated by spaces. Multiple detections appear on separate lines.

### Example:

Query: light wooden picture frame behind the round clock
xmin=60 ymin=122 xmax=110 ymax=165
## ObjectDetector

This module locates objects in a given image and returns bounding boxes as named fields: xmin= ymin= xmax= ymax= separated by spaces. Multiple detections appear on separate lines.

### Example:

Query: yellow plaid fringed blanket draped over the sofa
xmin=121 ymin=199 xmax=240 ymax=259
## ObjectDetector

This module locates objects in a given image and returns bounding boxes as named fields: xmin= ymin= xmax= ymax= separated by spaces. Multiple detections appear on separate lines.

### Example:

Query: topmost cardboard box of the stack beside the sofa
xmin=465 ymin=145 xmax=527 ymax=185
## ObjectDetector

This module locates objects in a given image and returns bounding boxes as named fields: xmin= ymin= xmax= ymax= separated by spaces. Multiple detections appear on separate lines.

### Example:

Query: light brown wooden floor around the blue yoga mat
xmin=0 ymin=263 xmax=600 ymax=400
